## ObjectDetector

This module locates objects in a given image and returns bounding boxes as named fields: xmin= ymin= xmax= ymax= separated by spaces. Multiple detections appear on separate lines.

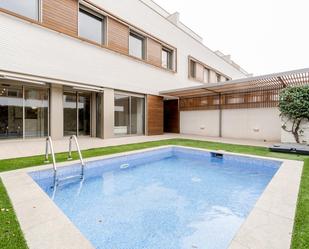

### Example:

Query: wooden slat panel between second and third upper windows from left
xmin=107 ymin=18 xmax=130 ymax=54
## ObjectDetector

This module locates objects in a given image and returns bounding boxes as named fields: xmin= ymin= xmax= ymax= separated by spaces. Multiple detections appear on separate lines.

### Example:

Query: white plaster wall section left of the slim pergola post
xmin=180 ymin=110 xmax=219 ymax=137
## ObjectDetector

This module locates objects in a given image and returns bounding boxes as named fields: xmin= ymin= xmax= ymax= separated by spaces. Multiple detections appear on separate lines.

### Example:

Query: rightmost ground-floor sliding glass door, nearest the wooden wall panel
xmin=114 ymin=94 xmax=145 ymax=136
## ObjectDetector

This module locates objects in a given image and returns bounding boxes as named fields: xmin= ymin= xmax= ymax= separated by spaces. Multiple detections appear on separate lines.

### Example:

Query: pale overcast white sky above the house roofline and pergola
xmin=154 ymin=0 xmax=309 ymax=75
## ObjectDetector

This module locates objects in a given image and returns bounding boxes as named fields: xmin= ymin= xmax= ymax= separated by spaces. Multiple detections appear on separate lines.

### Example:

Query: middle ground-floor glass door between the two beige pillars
xmin=63 ymin=92 xmax=91 ymax=136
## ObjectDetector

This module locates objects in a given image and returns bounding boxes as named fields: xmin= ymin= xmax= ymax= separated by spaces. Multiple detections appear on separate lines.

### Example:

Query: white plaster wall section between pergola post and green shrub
xmin=222 ymin=108 xmax=281 ymax=141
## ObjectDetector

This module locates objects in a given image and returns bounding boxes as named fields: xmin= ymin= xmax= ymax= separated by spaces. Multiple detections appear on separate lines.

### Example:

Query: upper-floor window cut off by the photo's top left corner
xmin=0 ymin=0 xmax=39 ymax=21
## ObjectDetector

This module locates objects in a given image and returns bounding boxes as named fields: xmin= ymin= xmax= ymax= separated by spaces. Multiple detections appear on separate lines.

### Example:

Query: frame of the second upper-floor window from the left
xmin=77 ymin=3 xmax=107 ymax=46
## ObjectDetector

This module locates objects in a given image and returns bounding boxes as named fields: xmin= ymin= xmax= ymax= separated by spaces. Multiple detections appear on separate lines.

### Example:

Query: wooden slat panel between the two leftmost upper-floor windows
xmin=42 ymin=0 xmax=78 ymax=36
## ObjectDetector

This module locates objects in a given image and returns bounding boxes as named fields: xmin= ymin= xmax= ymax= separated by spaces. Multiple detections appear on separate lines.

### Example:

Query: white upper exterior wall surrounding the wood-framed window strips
xmin=0 ymin=0 xmax=245 ymax=94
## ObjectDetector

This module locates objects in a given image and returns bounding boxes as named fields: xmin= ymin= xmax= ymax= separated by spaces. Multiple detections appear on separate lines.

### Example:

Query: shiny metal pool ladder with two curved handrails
xmin=45 ymin=135 xmax=85 ymax=185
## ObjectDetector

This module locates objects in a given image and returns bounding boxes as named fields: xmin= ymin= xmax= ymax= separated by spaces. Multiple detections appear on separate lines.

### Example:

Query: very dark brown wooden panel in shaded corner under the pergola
xmin=164 ymin=99 xmax=180 ymax=133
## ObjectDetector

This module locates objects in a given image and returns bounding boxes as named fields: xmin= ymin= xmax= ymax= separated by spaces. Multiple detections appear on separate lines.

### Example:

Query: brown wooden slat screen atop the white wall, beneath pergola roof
xmin=179 ymin=88 xmax=280 ymax=111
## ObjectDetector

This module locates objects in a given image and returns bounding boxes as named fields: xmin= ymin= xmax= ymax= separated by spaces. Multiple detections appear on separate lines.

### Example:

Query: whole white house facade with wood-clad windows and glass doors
xmin=0 ymin=0 xmax=247 ymax=140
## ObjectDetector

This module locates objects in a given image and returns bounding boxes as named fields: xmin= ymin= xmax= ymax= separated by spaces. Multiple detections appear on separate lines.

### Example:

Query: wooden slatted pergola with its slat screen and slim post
xmin=160 ymin=68 xmax=309 ymax=137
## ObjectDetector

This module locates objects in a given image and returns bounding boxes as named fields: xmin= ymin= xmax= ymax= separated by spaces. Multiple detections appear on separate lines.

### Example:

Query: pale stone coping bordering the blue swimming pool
xmin=0 ymin=145 xmax=303 ymax=249
